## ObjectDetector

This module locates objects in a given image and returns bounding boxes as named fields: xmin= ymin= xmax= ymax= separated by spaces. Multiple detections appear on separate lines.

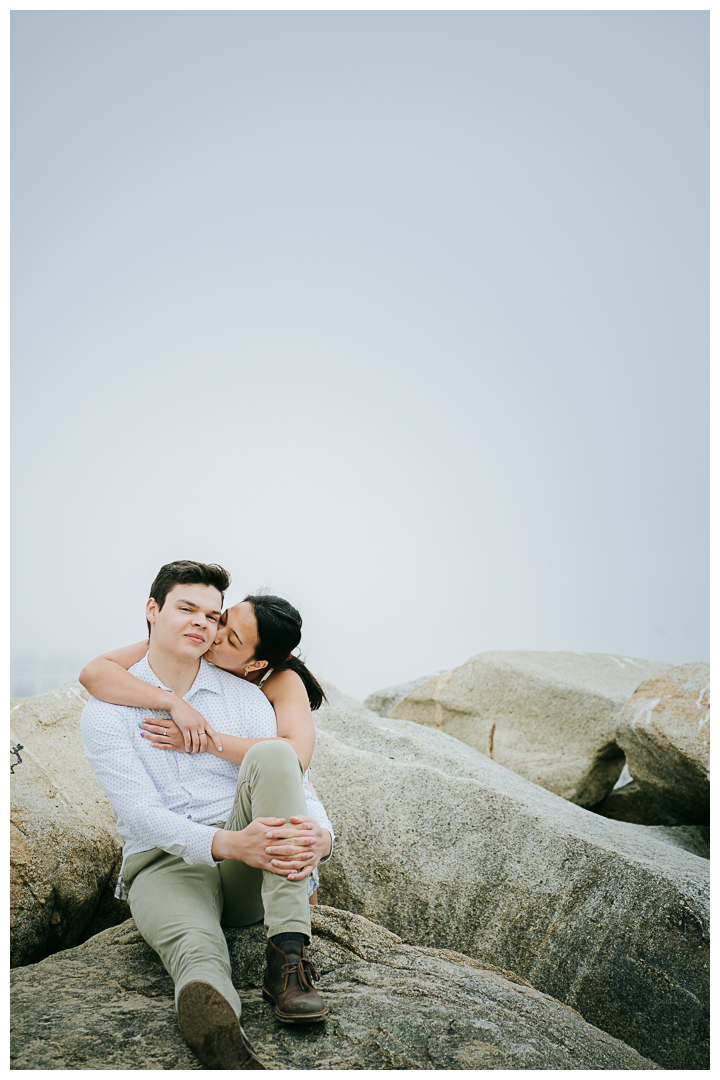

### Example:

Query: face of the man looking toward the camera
xmin=146 ymin=585 xmax=222 ymax=663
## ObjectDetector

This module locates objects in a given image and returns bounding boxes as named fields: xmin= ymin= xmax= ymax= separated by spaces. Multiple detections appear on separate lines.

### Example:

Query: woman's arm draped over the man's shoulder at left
xmin=80 ymin=642 xmax=219 ymax=754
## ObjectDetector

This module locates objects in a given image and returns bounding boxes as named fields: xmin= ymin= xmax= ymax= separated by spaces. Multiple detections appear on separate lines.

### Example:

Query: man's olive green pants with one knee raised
xmin=123 ymin=741 xmax=310 ymax=1016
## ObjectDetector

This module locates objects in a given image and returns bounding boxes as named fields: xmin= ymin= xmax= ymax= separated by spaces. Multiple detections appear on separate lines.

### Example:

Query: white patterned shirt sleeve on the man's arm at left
xmin=81 ymin=698 xmax=217 ymax=866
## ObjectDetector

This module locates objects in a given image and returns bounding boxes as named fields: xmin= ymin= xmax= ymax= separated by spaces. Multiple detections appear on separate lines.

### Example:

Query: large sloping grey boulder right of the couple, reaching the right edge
xmin=313 ymin=707 xmax=709 ymax=1069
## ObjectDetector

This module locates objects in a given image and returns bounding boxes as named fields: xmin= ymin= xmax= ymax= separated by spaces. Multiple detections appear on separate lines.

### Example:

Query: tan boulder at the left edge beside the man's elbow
xmin=10 ymin=683 xmax=127 ymax=967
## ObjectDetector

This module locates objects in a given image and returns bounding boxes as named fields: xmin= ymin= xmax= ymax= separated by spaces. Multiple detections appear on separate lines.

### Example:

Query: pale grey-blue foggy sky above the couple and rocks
xmin=11 ymin=11 xmax=709 ymax=698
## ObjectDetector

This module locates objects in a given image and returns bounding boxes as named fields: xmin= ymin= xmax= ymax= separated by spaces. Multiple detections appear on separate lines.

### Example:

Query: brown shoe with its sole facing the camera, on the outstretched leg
xmin=177 ymin=980 xmax=264 ymax=1069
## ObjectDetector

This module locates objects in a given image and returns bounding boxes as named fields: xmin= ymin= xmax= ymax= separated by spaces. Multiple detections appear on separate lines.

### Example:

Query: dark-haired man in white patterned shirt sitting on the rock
xmin=81 ymin=561 xmax=332 ymax=1069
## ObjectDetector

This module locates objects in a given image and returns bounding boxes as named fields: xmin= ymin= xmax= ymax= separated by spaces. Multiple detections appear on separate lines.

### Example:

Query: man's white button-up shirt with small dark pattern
xmin=81 ymin=656 xmax=334 ymax=881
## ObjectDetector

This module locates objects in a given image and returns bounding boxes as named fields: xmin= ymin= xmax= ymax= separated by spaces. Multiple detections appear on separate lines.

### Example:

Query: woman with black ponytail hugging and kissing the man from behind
xmin=80 ymin=595 xmax=327 ymax=904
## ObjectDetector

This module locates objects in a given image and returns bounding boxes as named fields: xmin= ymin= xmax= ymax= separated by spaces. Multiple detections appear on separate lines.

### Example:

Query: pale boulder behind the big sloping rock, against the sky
xmin=379 ymin=652 xmax=667 ymax=807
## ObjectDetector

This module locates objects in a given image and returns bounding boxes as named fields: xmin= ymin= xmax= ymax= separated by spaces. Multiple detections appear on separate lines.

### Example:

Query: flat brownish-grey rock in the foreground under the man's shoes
xmin=11 ymin=907 xmax=657 ymax=1070
